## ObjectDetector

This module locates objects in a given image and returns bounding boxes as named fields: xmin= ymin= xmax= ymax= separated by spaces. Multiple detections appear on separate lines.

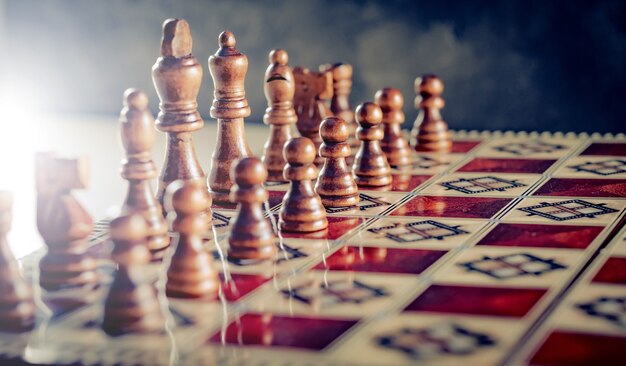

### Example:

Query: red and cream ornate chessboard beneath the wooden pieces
xmin=0 ymin=131 xmax=626 ymax=365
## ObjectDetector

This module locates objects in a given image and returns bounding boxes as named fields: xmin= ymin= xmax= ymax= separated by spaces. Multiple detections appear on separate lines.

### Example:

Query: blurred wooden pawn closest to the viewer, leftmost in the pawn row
xmin=102 ymin=214 xmax=165 ymax=336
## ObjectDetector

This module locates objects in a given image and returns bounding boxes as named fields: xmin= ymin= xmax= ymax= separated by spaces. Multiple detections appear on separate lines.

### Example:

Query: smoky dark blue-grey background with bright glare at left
xmin=0 ymin=0 xmax=626 ymax=132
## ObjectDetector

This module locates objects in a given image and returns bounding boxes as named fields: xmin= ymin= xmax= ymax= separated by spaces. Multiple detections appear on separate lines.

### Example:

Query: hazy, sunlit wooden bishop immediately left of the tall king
xmin=119 ymin=89 xmax=170 ymax=260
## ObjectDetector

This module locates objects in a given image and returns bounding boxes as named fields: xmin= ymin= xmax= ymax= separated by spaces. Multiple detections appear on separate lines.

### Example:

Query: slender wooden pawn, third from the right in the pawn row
xmin=352 ymin=102 xmax=391 ymax=187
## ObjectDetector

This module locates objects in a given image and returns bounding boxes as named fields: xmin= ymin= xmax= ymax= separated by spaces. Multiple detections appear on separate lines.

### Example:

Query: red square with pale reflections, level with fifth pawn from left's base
xmin=391 ymin=196 xmax=511 ymax=218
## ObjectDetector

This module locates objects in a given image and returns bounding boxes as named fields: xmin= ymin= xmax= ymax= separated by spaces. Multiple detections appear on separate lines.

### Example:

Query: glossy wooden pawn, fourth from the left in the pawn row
xmin=279 ymin=137 xmax=328 ymax=233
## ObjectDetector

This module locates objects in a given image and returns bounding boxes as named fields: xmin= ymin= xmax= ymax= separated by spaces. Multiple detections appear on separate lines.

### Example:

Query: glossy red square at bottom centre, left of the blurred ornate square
xmin=209 ymin=313 xmax=356 ymax=351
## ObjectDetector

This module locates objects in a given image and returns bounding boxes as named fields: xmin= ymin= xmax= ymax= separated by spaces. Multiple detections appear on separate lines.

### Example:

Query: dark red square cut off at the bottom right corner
xmin=529 ymin=330 xmax=626 ymax=366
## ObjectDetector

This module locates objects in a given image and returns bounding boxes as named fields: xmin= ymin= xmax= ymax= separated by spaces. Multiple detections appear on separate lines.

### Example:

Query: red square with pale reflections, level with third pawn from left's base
xmin=315 ymin=246 xmax=446 ymax=274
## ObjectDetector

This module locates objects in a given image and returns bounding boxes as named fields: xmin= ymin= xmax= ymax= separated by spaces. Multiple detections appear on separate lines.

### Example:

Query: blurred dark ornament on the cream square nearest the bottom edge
xmin=375 ymin=323 xmax=496 ymax=359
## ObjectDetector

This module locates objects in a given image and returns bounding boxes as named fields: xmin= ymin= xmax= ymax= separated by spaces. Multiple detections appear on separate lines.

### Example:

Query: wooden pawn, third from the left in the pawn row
xmin=228 ymin=157 xmax=276 ymax=260
